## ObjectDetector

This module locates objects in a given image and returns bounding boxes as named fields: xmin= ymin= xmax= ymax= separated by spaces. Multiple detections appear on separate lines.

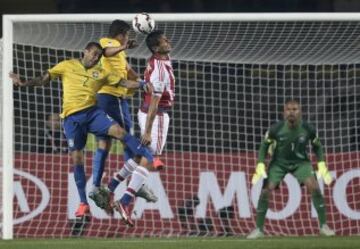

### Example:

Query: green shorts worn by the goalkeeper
xmin=266 ymin=162 xmax=315 ymax=186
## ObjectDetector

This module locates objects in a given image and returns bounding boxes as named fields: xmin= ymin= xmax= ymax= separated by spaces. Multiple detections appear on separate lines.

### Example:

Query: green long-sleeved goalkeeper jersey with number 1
xmin=258 ymin=121 xmax=324 ymax=165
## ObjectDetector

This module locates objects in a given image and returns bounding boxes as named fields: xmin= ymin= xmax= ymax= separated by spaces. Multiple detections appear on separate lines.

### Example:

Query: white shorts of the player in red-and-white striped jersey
xmin=138 ymin=110 xmax=170 ymax=156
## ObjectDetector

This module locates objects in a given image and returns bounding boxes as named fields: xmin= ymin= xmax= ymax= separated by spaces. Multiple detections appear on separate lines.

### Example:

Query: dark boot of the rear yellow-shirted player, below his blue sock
xmin=89 ymin=186 xmax=114 ymax=215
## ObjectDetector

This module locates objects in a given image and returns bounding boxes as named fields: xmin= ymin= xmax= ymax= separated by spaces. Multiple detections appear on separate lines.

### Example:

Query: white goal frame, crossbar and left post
xmin=1 ymin=13 xmax=360 ymax=239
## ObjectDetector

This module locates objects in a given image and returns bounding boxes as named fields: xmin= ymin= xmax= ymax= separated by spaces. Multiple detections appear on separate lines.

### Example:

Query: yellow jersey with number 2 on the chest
xmin=48 ymin=59 xmax=120 ymax=118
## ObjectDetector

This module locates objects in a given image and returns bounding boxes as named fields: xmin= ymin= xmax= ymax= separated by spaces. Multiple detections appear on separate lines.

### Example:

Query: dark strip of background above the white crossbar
xmin=0 ymin=0 xmax=360 ymax=37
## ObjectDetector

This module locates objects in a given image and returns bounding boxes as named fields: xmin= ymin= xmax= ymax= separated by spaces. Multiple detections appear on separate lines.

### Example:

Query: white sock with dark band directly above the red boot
xmin=120 ymin=166 xmax=149 ymax=205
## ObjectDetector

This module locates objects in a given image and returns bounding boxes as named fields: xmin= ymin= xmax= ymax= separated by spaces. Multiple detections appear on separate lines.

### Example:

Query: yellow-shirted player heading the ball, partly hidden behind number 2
xmin=89 ymin=20 xmax=157 ymax=209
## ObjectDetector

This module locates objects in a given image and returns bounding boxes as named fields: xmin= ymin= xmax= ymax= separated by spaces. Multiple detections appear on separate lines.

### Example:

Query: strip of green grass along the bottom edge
xmin=0 ymin=236 xmax=360 ymax=249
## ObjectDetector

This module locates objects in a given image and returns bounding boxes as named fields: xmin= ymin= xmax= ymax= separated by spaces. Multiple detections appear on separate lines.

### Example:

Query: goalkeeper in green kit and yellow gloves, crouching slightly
xmin=247 ymin=100 xmax=335 ymax=239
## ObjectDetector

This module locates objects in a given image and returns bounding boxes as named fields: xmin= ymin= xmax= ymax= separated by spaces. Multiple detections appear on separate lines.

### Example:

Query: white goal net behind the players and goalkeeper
xmin=2 ymin=14 xmax=360 ymax=238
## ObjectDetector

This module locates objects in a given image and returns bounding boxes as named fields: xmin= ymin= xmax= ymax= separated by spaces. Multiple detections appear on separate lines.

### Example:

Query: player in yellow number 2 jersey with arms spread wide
xmin=10 ymin=42 xmax=153 ymax=226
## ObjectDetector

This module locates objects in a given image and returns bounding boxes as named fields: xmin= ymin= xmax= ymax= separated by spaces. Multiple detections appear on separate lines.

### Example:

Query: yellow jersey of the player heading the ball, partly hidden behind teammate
xmin=99 ymin=37 xmax=135 ymax=98
